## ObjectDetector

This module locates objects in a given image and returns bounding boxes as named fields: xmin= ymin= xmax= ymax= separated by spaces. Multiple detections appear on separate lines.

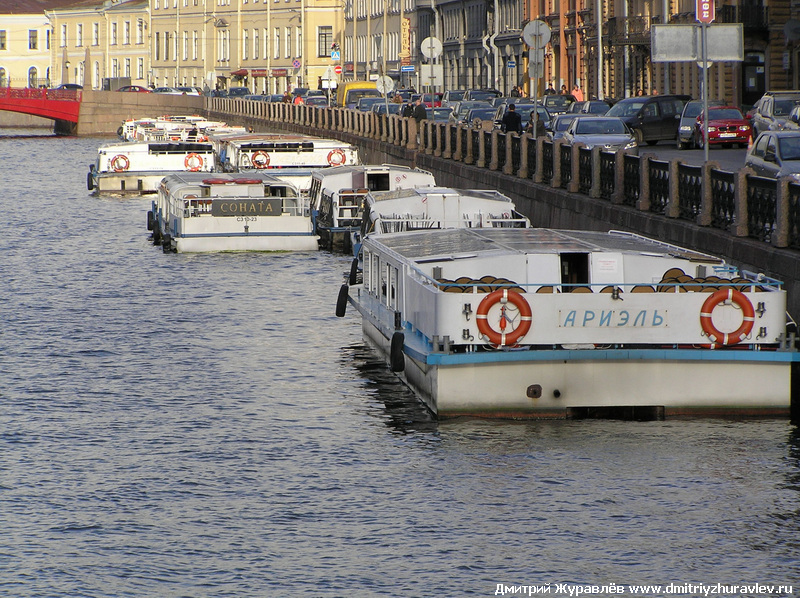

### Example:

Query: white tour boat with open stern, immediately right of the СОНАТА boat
xmin=309 ymin=164 xmax=436 ymax=253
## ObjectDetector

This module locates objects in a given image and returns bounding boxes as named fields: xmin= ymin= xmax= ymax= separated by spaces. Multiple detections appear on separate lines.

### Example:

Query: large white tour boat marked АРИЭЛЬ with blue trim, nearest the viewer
xmin=336 ymin=228 xmax=800 ymax=419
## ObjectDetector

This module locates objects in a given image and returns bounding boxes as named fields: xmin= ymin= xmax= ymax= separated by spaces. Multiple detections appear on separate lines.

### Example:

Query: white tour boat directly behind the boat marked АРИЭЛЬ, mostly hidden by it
xmin=351 ymin=187 xmax=530 ymax=256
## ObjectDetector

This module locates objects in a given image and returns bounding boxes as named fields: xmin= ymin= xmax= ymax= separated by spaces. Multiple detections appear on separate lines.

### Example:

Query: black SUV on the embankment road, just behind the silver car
xmin=605 ymin=95 xmax=691 ymax=145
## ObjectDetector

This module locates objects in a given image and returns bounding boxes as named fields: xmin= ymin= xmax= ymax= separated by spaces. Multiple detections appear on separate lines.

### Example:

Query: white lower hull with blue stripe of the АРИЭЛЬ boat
xmin=363 ymin=318 xmax=796 ymax=418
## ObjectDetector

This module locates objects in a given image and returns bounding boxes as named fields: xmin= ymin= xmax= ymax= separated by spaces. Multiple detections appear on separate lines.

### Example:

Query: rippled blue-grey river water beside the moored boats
xmin=0 ymin=130 xmax=800 ymax=598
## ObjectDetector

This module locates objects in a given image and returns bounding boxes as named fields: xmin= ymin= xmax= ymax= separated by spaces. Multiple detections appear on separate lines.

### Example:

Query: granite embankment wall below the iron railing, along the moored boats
xmin=67 ymin=92 xmax=800 ymax=318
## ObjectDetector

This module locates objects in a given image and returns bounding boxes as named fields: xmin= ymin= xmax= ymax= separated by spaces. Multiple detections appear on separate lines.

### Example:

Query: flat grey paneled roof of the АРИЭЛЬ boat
xmin=367 ymin=228 xmax=724 ymax=264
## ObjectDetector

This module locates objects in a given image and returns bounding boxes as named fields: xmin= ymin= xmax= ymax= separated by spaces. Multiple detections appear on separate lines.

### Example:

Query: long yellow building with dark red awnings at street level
xmin=151 ymin=0 xmax=343 ymax=93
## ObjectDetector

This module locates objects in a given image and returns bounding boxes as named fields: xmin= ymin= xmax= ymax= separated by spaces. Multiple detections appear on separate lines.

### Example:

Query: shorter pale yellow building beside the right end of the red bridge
xmin=45 ymin=0 xmax=150 ymax=90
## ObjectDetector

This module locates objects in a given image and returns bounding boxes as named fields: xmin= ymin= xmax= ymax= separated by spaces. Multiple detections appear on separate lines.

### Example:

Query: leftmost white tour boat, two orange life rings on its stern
xmin=86 ymin=141 xmax=215 ymax=194
